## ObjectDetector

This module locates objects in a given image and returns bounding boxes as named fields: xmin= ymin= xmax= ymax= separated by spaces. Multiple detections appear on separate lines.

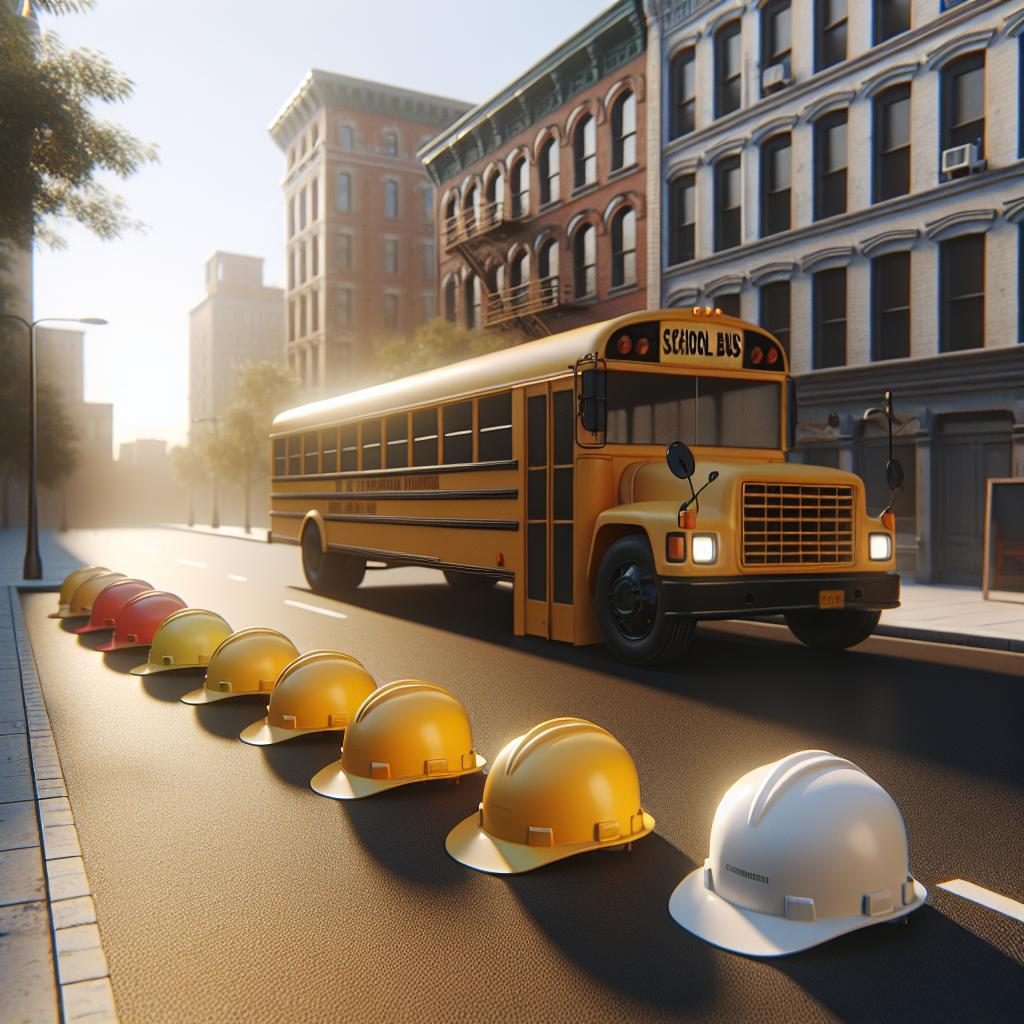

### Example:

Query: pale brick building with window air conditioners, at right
xmin=645 ymin=0 xmax=1024 ymax=584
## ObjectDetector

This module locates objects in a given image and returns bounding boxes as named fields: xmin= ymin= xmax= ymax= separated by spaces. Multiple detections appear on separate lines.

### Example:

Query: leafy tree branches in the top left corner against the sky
xmin=0 ymin=0 xmax=156 ymax=246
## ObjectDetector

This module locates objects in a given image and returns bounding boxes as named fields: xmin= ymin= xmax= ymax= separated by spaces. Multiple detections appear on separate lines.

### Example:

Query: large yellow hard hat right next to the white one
xmin=444 ymin=718 xmax=654 ymax=874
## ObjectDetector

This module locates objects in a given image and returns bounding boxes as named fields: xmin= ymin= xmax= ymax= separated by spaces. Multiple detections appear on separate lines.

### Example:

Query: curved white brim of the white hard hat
xmin=669 ymin=866 xmax=928 ymax=956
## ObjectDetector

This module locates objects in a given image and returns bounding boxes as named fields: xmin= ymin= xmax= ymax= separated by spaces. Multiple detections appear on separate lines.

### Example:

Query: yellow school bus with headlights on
xmin=270 ymin=307 xmax=899 ymax=665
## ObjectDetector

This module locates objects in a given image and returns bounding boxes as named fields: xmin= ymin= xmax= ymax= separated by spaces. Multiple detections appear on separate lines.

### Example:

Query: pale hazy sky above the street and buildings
xmin=35 ymin=0 xmax=610 ymax=443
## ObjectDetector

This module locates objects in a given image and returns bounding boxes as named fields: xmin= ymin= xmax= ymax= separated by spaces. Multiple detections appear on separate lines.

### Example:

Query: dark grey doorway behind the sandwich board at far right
xmin=933 ymin=413 xmax=1011 ymax=587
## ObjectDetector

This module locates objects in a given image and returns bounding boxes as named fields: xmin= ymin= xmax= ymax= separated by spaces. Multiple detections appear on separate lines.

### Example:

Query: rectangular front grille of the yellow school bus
xmin=743 ymin=483 xmax=854 ymax=565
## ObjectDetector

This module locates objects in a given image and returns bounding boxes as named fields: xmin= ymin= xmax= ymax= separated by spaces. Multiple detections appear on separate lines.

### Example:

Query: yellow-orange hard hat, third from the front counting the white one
xmin=309 ymin=679 xmax=486 ymax=800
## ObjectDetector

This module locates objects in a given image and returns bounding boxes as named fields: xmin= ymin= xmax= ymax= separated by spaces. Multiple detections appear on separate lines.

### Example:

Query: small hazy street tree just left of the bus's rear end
xmin=206 ymin=362 xmax=299 ymax=534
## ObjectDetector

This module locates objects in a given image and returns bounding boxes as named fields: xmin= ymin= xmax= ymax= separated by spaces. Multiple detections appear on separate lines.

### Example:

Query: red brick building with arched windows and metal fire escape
xmin=420 ymin=0 xmax=656 ymax=337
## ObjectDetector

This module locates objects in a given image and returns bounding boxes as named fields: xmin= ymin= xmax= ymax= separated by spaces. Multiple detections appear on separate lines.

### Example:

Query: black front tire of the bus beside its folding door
xmin=596 ymin=535 xmax=696 ymax=665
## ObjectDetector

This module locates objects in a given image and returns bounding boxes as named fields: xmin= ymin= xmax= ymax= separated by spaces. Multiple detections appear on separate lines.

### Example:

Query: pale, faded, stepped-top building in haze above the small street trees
xmin=188 ymin=252 xmax=285 ymax=429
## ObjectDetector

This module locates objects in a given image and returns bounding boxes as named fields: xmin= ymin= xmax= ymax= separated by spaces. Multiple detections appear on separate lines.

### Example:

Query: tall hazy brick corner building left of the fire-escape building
xmin=269 ymin=70 xmax=469 ymax=396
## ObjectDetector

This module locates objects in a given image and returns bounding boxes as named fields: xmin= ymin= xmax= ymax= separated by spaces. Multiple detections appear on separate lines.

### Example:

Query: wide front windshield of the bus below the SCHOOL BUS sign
xmin=606 ymin=370 xmax=781 ymax=449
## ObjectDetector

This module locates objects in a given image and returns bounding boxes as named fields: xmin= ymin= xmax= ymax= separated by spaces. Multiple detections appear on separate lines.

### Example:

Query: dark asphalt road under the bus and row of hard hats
xmin=23 ymin=530 xmax=1024 ymax=1024
